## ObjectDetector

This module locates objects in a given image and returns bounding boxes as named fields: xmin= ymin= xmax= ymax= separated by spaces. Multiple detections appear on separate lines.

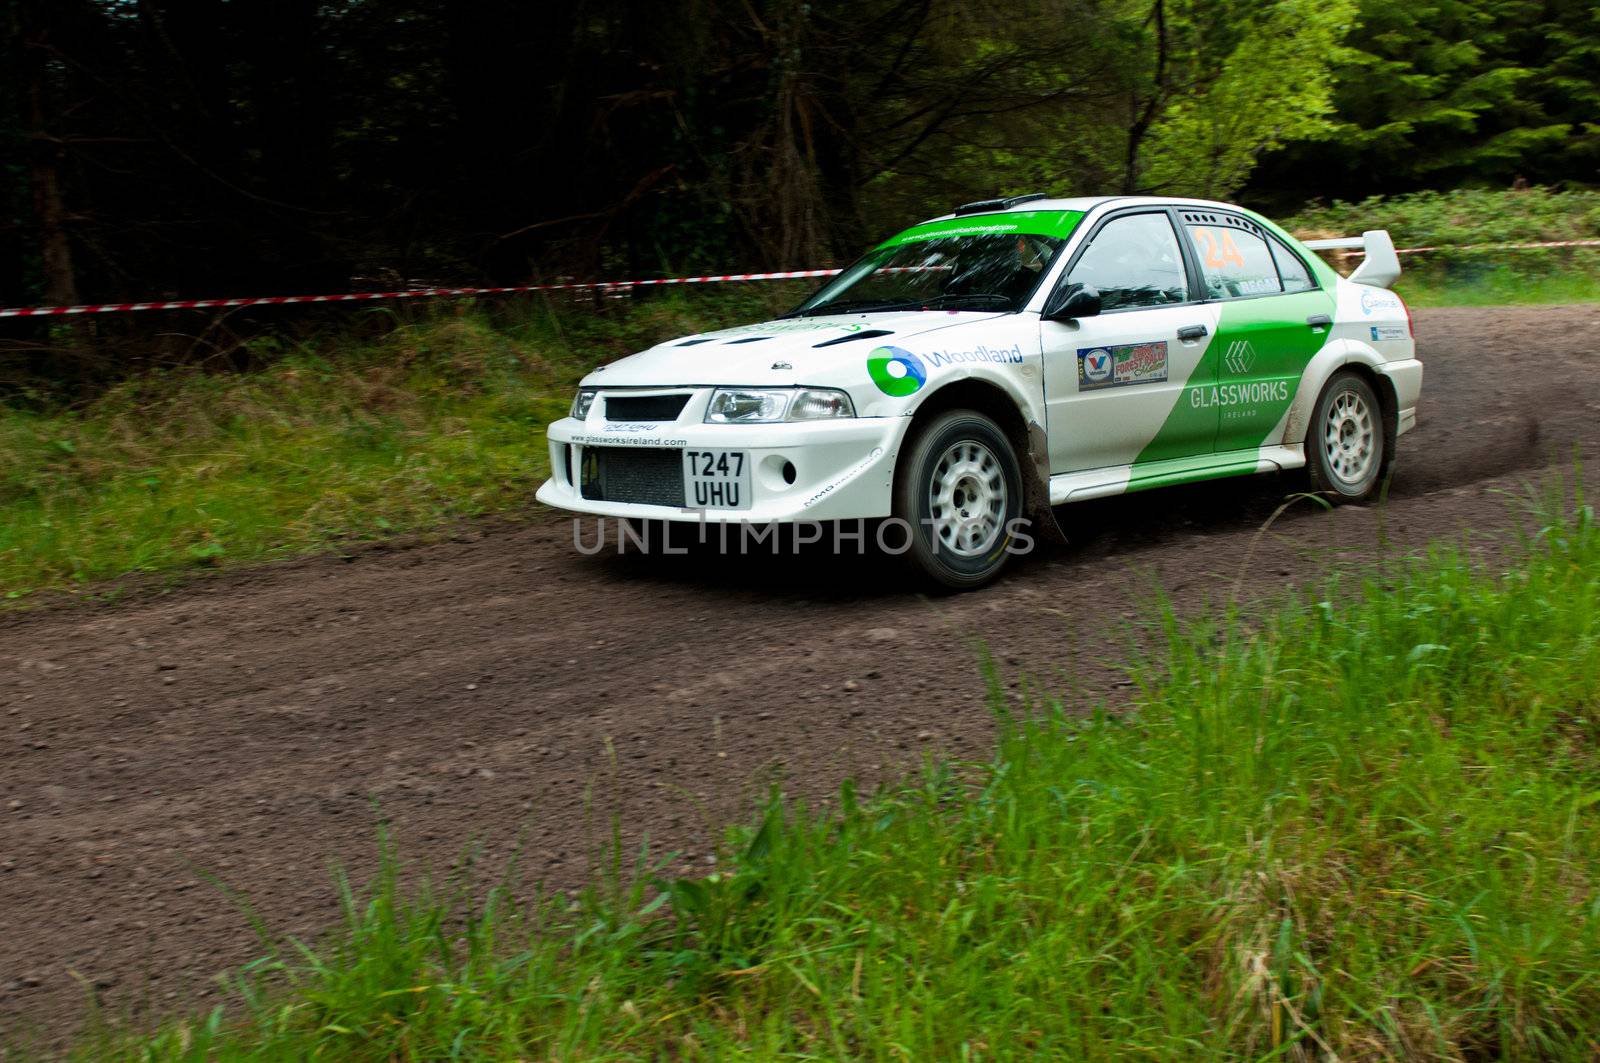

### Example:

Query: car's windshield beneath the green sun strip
xmin=790 ymin=232 xmax=1066 ymax=317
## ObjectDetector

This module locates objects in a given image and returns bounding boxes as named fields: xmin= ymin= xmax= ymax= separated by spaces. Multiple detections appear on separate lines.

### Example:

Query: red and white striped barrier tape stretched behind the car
xmin=0 ymin=240 xmax=1600 ymax=317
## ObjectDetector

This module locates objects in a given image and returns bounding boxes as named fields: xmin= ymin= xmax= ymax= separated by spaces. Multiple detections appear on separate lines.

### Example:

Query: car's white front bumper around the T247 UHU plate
xmin=538 ymin=402 xmax=910 ymax=523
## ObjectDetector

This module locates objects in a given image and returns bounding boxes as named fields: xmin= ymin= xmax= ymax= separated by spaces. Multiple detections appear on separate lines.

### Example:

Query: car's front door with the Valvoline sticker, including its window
xmin=1040 ymin=207 xmax=1218 ymax=474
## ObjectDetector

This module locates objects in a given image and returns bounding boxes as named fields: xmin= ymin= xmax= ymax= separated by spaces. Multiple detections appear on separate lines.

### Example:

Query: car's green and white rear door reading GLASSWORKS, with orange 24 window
xmin=1181 ymin=208 xmax=1334 ymax=453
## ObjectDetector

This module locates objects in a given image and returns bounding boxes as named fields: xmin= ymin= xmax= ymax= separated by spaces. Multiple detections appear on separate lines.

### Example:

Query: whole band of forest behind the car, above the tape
xmin=9 ymin=0 xmax=1600 ymax=312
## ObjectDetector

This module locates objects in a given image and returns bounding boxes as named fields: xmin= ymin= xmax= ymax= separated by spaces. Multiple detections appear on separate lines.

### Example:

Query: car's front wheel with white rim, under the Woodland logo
xmin=894 ymin=410 xmax=1022 ymax=591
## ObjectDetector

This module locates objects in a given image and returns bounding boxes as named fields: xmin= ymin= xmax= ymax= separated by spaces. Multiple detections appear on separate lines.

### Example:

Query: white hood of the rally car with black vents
xmin=582 ymin=311 xmax=1010 ymax=387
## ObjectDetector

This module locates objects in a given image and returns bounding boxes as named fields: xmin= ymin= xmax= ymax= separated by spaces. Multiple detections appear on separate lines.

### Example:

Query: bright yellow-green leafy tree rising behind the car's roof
xmin=866 ymin=0 xmax=1355 ymax=218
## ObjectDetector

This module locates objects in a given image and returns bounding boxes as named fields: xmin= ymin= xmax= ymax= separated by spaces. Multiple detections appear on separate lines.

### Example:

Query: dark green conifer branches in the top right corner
xmin=1253 ymin=0 xmax=1600 ymax=203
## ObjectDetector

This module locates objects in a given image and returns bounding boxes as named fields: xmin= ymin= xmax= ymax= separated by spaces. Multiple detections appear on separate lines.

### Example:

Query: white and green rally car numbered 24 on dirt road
xmin=538 ymin=195 xmax=1422 ymax=588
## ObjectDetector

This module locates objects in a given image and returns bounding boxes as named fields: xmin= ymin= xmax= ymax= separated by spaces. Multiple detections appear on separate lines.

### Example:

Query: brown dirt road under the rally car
xmin=0 ymin=306 xmax=1600 ymax=1041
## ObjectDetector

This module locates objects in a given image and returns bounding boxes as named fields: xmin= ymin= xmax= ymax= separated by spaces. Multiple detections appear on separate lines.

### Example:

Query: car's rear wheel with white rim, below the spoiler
xmin=1306 ymin=371 xmax=1394 ymax=503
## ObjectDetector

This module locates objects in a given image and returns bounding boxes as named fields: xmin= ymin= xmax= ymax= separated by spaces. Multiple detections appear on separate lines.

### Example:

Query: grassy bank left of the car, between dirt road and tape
xmin=0 ymin=291 xmax=792 ymax=605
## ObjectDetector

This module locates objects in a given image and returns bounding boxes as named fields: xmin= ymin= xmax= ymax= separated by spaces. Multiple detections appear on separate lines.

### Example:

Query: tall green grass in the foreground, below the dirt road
xmin=68 ymin=486 xmax=1600 ymax=1060
